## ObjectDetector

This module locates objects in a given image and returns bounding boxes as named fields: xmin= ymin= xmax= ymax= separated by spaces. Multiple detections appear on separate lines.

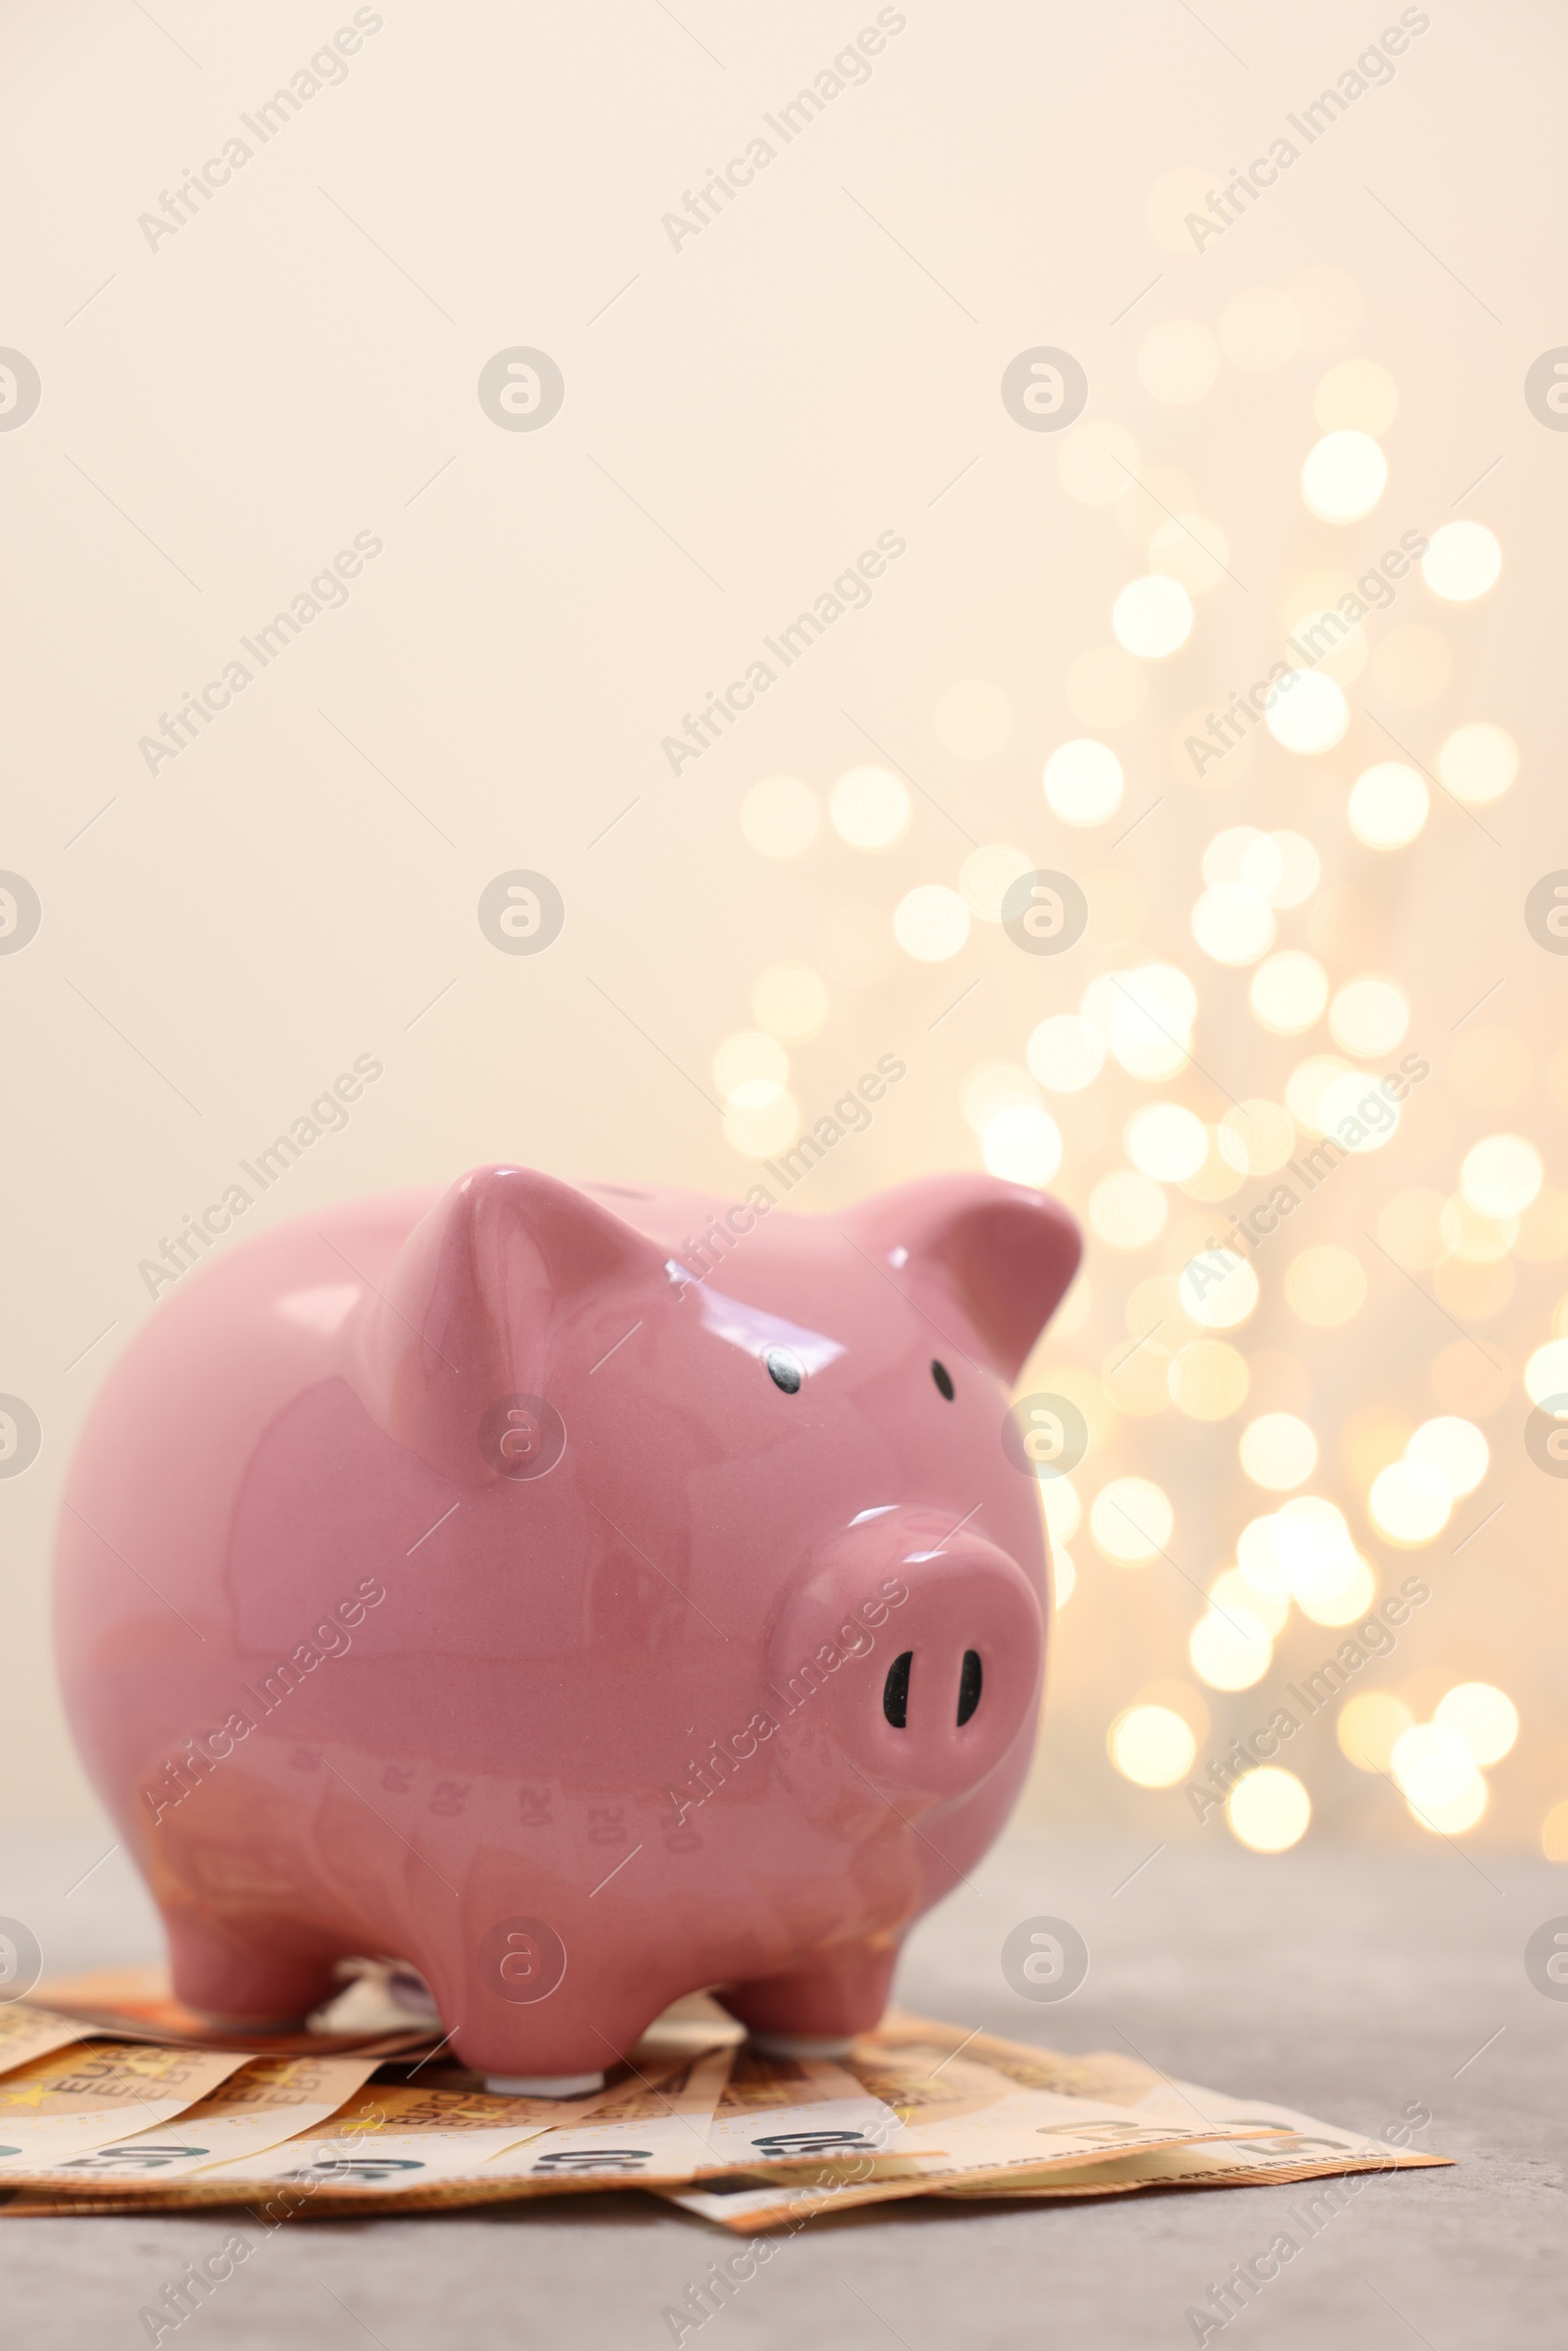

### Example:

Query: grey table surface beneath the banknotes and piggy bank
xmin=0 ymin=1832 xmax=1568 ymax=2351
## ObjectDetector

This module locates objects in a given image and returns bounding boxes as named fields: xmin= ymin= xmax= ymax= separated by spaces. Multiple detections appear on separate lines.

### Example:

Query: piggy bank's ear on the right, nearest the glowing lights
xmin=847 ymin=1176 xmax=1084 ymax=1383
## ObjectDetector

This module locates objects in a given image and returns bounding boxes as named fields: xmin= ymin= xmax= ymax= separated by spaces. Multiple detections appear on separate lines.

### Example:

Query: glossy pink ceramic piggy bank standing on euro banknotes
xmin=57 ymin=1166 xmax=1079 ymax=2095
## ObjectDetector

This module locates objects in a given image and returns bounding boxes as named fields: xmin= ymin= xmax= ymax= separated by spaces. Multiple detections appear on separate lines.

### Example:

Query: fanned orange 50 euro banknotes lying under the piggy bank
xmin=0 ymin=1968 xmax=1448 ymax=2235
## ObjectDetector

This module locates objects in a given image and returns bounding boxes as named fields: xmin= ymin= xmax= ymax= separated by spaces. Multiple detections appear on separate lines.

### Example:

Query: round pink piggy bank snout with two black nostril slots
xmin=776 ymin=1538 xmax=1044 ymax=1805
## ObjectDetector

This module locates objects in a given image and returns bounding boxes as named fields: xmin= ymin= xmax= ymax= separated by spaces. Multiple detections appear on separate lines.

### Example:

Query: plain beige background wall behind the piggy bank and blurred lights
xmin=0 ymin=0 xmax=1568 ymax=1845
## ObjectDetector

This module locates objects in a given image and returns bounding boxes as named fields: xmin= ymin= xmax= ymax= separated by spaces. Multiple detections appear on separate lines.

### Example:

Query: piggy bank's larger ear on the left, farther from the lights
xmin=362 ymin=1168 xmax=662 ymax=1486
